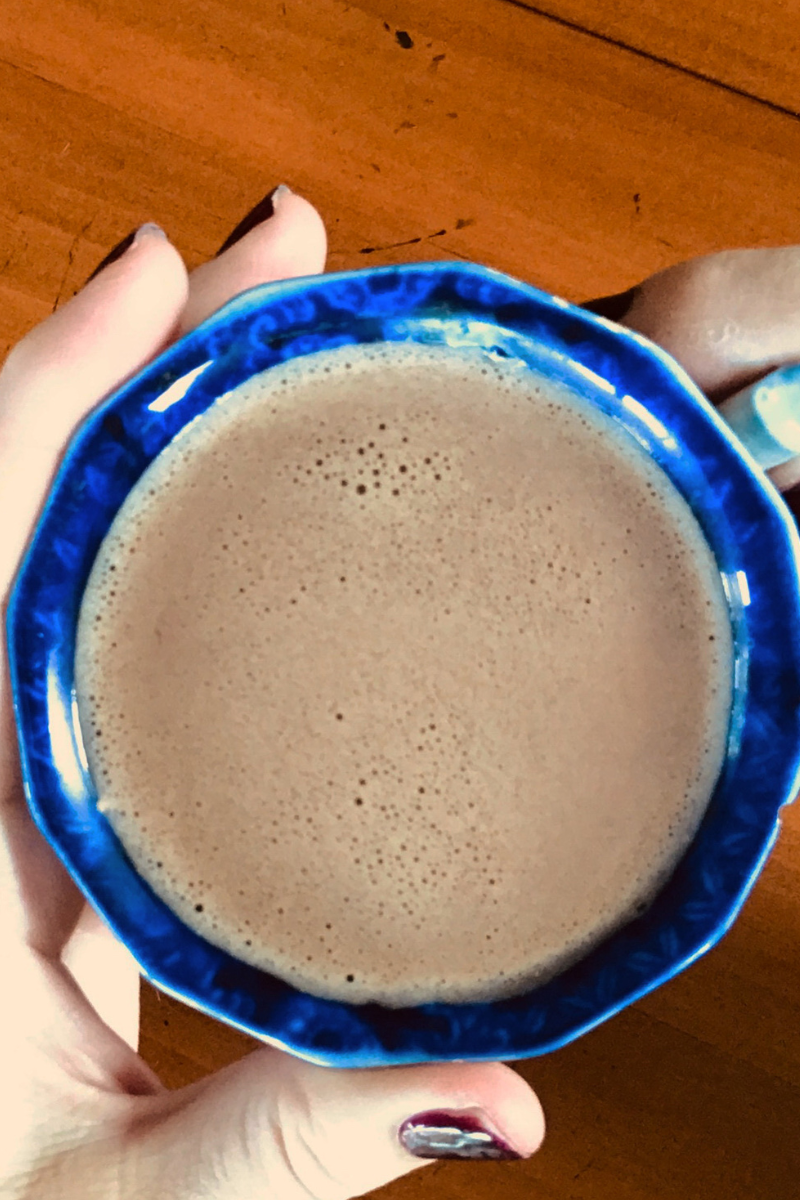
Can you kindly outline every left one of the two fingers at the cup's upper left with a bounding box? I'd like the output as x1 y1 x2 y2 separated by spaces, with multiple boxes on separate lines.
0 227 188 596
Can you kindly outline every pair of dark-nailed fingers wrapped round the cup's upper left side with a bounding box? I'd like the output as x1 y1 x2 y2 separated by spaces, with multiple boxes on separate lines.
0 188 326 595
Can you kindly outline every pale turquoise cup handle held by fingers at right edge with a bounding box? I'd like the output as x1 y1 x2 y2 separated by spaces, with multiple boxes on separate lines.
717 364 800 470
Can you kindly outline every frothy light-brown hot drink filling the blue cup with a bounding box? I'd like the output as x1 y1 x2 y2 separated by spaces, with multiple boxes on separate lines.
76 346 733 1006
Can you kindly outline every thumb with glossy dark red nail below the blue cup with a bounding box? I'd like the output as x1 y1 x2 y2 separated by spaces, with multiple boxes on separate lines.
134 1048 545 1200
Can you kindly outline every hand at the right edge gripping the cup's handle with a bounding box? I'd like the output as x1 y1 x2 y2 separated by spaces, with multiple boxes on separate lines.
583 246 800 501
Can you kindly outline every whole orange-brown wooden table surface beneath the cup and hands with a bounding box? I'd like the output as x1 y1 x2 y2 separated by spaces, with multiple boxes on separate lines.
0 0 800 1200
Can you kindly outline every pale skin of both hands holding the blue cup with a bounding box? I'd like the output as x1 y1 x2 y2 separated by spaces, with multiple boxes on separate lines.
0 194 800 1200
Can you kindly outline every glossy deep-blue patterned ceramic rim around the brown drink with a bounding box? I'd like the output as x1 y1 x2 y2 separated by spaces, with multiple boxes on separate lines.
8 263 800 1067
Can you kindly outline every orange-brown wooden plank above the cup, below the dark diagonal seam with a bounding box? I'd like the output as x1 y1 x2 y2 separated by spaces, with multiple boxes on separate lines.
0 0 800 350
